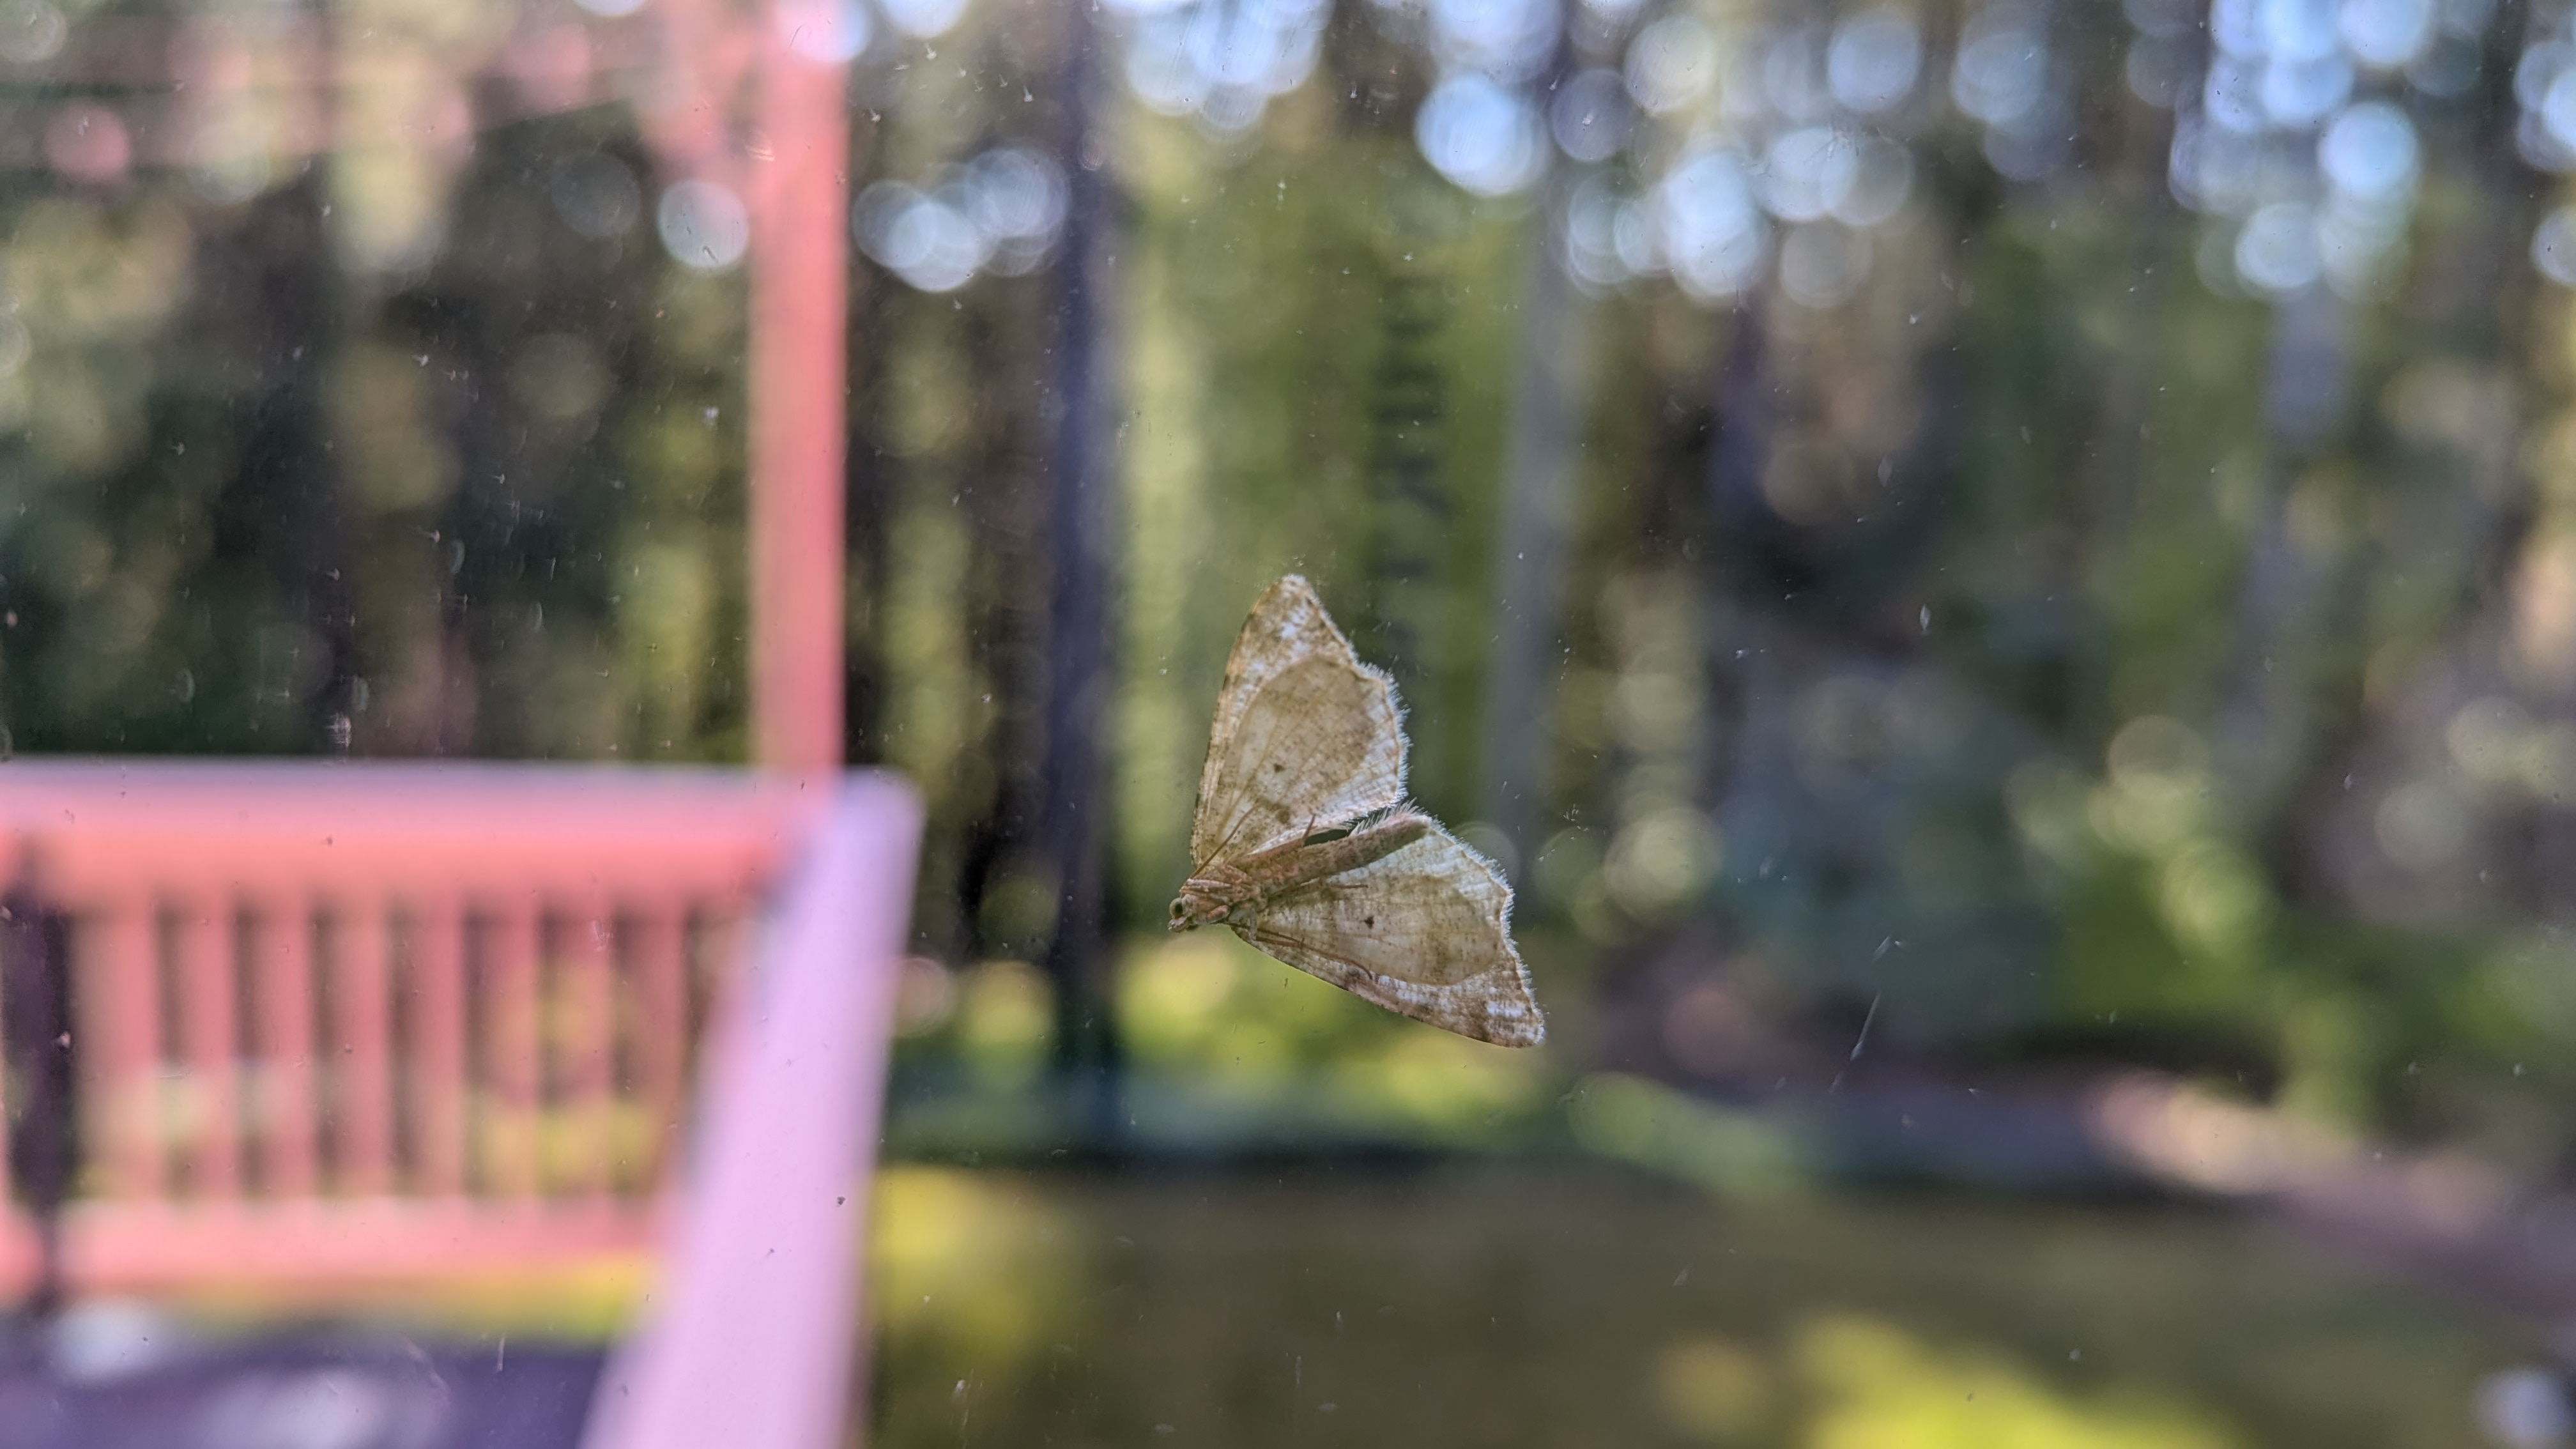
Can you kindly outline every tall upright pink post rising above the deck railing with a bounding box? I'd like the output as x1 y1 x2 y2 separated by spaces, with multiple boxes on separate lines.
749 0 850 771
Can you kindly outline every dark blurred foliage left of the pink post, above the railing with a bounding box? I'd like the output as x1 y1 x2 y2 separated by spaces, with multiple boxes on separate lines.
0 119 742 758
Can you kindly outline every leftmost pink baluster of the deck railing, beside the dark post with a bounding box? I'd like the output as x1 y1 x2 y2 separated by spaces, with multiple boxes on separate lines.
88 894 162 1199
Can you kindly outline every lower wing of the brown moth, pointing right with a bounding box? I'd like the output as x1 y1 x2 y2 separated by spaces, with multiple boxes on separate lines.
1234 827 1548 1046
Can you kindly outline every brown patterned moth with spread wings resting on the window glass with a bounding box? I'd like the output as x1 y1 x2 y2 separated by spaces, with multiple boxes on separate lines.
1170 575 1548 1046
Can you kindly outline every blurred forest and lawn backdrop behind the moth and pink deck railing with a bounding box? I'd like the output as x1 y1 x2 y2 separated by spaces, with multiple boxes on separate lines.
15 0 2576 1449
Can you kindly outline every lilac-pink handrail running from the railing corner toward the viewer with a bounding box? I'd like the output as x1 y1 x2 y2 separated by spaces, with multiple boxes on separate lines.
582 779 919 1449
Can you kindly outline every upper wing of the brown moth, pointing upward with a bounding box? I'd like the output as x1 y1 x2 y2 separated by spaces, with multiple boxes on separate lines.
1190 575 1404 869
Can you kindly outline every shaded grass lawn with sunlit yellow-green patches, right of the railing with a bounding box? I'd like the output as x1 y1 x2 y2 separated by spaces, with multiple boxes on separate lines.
871 1160 2543 1449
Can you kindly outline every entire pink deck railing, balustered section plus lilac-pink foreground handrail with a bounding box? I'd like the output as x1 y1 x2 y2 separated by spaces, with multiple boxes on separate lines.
0 760 919 1449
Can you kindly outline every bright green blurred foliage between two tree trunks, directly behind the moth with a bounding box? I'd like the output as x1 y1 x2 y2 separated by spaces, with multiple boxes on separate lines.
1118 105 1525 921
